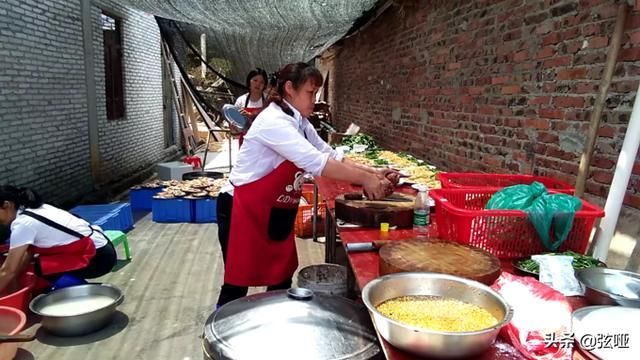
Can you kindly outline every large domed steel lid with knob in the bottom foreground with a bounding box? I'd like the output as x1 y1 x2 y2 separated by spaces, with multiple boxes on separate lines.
202 288 382 360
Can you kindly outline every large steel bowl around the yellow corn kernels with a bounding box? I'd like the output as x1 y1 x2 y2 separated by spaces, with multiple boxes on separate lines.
362 272 513 358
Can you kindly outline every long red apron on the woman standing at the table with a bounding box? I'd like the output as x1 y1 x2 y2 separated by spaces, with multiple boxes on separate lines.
224 160 304 286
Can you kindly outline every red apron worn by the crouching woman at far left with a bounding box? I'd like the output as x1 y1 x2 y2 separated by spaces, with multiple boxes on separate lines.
31 236 96 276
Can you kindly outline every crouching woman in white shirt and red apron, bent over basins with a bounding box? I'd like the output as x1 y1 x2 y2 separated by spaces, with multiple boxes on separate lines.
0 185 116 291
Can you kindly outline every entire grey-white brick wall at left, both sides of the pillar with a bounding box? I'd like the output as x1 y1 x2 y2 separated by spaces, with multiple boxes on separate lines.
0 0 175 203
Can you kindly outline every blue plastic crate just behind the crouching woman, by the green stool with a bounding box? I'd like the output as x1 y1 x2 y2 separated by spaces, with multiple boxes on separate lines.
70 203 133 232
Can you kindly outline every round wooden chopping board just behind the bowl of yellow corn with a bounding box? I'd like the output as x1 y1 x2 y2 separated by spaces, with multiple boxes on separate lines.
379 240 501 285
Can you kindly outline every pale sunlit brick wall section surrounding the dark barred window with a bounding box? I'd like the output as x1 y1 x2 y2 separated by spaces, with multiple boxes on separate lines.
92 0 174 181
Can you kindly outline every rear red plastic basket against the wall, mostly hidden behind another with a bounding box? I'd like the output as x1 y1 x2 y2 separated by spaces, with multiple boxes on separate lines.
437 172 575 195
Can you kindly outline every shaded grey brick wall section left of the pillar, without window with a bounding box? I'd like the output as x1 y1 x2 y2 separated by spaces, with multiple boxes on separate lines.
0 0 92 202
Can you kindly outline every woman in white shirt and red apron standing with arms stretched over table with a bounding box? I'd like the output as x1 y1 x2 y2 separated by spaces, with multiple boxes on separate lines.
218 63 398 306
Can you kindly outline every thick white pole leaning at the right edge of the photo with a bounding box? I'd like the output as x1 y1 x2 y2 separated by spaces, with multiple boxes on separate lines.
593 80 640 261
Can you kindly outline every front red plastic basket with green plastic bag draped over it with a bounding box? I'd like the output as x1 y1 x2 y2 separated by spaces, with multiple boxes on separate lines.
429 188 604 259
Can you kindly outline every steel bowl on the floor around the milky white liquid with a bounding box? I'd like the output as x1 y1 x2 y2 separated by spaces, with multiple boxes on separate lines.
29 284 124 336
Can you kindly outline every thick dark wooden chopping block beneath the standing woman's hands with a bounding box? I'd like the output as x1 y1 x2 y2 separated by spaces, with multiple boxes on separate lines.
335 192 415 228
